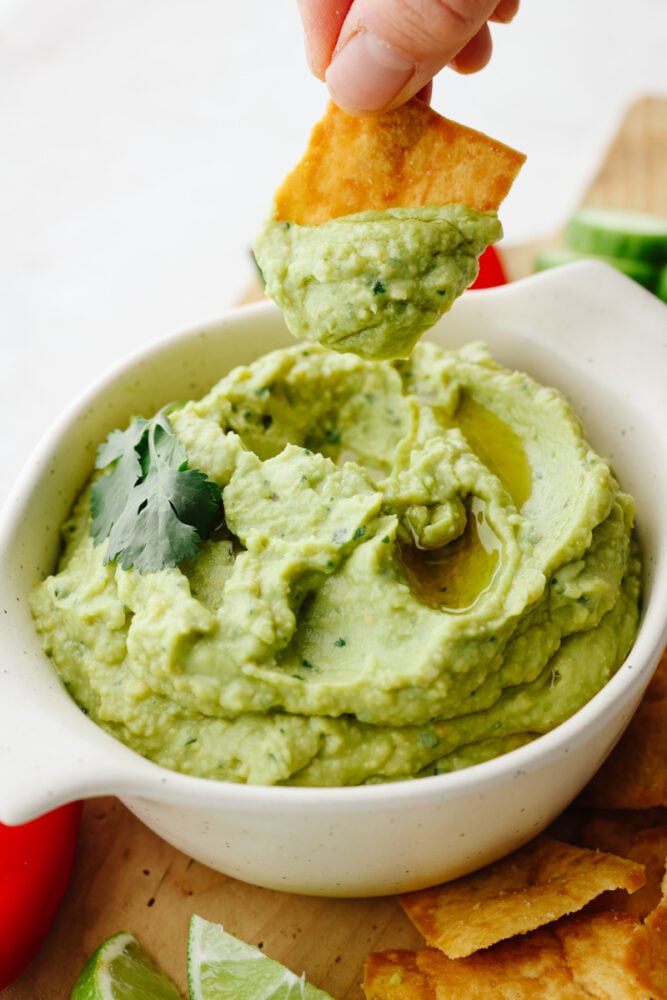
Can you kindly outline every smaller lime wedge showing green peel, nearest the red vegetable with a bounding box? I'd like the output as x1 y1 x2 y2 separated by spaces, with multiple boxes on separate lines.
72 931 181 1000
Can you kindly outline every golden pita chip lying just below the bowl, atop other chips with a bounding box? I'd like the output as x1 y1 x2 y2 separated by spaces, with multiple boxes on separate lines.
399 835 645 958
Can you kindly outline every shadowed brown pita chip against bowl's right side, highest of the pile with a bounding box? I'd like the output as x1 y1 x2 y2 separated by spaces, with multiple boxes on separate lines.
580 653 667 809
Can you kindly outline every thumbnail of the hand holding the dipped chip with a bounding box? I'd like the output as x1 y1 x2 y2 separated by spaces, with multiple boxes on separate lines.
325 31 415 111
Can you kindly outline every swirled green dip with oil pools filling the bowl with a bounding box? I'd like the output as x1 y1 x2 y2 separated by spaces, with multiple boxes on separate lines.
32 342 640 786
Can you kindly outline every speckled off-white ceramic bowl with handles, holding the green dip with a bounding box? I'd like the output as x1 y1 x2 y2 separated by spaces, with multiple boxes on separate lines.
0 264 667 896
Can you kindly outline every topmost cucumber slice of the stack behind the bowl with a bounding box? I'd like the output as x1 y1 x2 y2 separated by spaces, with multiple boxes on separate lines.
565 206 667 264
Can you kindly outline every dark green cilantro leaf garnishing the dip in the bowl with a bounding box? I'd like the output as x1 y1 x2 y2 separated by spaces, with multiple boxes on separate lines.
90 410 222 573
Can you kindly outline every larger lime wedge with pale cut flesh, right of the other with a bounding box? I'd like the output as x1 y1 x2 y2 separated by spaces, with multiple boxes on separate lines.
188 916 331 1000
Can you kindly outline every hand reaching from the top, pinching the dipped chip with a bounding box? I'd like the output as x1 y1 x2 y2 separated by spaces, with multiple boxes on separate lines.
297 0 519 113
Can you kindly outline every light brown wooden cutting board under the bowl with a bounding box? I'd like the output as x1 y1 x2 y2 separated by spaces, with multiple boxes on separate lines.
3 97 667 1000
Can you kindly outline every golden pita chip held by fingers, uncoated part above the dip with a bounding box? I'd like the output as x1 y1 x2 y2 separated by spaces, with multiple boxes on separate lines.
274 97 525 225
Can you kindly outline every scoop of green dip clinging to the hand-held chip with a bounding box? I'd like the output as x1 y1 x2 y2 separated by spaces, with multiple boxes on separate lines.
254 204 502 359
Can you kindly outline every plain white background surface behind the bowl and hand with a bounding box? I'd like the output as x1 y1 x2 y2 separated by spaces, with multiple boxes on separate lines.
0 0 667 502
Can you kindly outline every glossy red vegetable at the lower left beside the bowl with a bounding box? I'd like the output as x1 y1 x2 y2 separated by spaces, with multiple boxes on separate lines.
0 802 81 990
